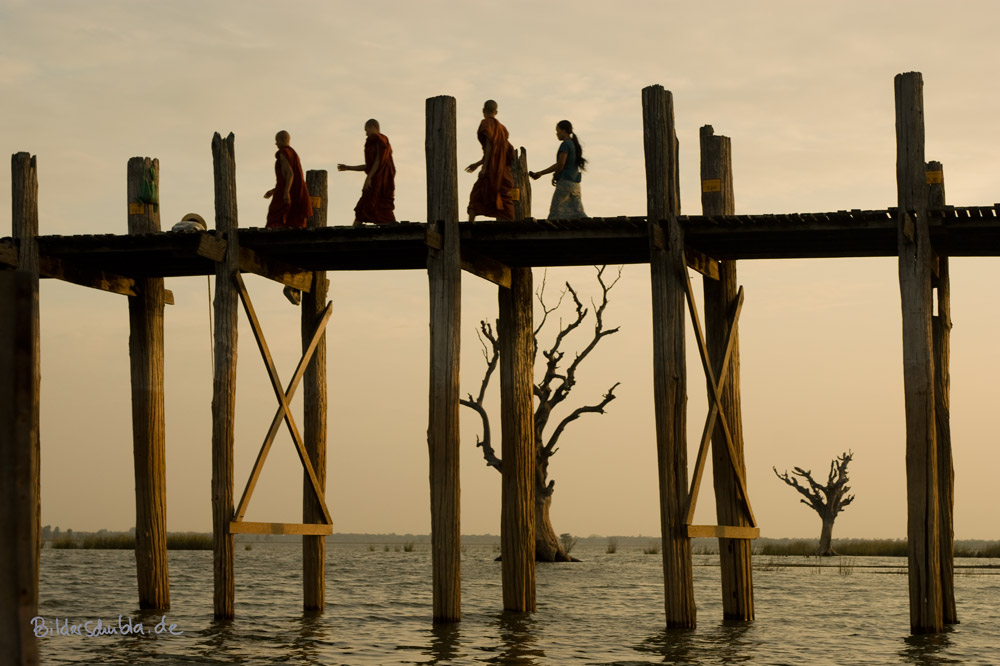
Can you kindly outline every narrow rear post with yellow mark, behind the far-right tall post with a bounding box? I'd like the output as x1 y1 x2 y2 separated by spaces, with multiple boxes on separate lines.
926 162 958 624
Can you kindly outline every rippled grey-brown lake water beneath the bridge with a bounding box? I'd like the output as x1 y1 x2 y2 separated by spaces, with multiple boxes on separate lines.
39 544 1000 666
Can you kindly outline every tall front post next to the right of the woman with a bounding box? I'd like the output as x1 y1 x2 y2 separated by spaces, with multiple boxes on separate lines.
642 86 697 627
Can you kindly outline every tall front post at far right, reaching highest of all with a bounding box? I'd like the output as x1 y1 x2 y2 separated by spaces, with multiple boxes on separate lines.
895 72 943 633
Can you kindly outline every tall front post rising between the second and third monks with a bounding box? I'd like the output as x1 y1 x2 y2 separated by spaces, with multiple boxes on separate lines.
424 96 462 622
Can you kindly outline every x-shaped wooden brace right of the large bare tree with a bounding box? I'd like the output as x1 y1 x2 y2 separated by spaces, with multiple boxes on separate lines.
681 255 757 527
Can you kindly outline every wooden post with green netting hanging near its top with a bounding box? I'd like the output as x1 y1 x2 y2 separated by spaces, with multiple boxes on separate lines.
127 157 170 609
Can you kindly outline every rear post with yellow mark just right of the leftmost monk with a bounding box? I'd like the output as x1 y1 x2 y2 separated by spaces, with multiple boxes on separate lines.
301 171 329 610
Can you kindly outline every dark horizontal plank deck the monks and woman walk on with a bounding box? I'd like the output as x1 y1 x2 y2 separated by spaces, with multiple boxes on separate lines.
0 204 1000 278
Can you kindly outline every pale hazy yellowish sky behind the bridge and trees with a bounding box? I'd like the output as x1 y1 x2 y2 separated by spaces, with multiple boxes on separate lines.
0 0 1000 539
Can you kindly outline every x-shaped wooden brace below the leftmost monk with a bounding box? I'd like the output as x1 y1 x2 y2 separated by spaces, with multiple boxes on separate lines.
233 272 333 525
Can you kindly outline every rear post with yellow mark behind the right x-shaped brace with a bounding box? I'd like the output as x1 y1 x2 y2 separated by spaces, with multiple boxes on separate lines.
701 125 754 620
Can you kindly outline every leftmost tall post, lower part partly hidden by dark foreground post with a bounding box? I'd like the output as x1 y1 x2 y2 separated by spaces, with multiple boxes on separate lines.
10 153 42 624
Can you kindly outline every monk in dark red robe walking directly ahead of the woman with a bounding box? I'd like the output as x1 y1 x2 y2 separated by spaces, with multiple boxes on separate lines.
465 99 514 222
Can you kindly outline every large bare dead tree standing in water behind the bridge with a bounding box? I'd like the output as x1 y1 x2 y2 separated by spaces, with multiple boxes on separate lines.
461 266 621 562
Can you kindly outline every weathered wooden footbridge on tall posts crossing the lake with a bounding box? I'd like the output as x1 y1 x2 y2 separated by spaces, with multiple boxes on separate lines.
0 73 984 654
